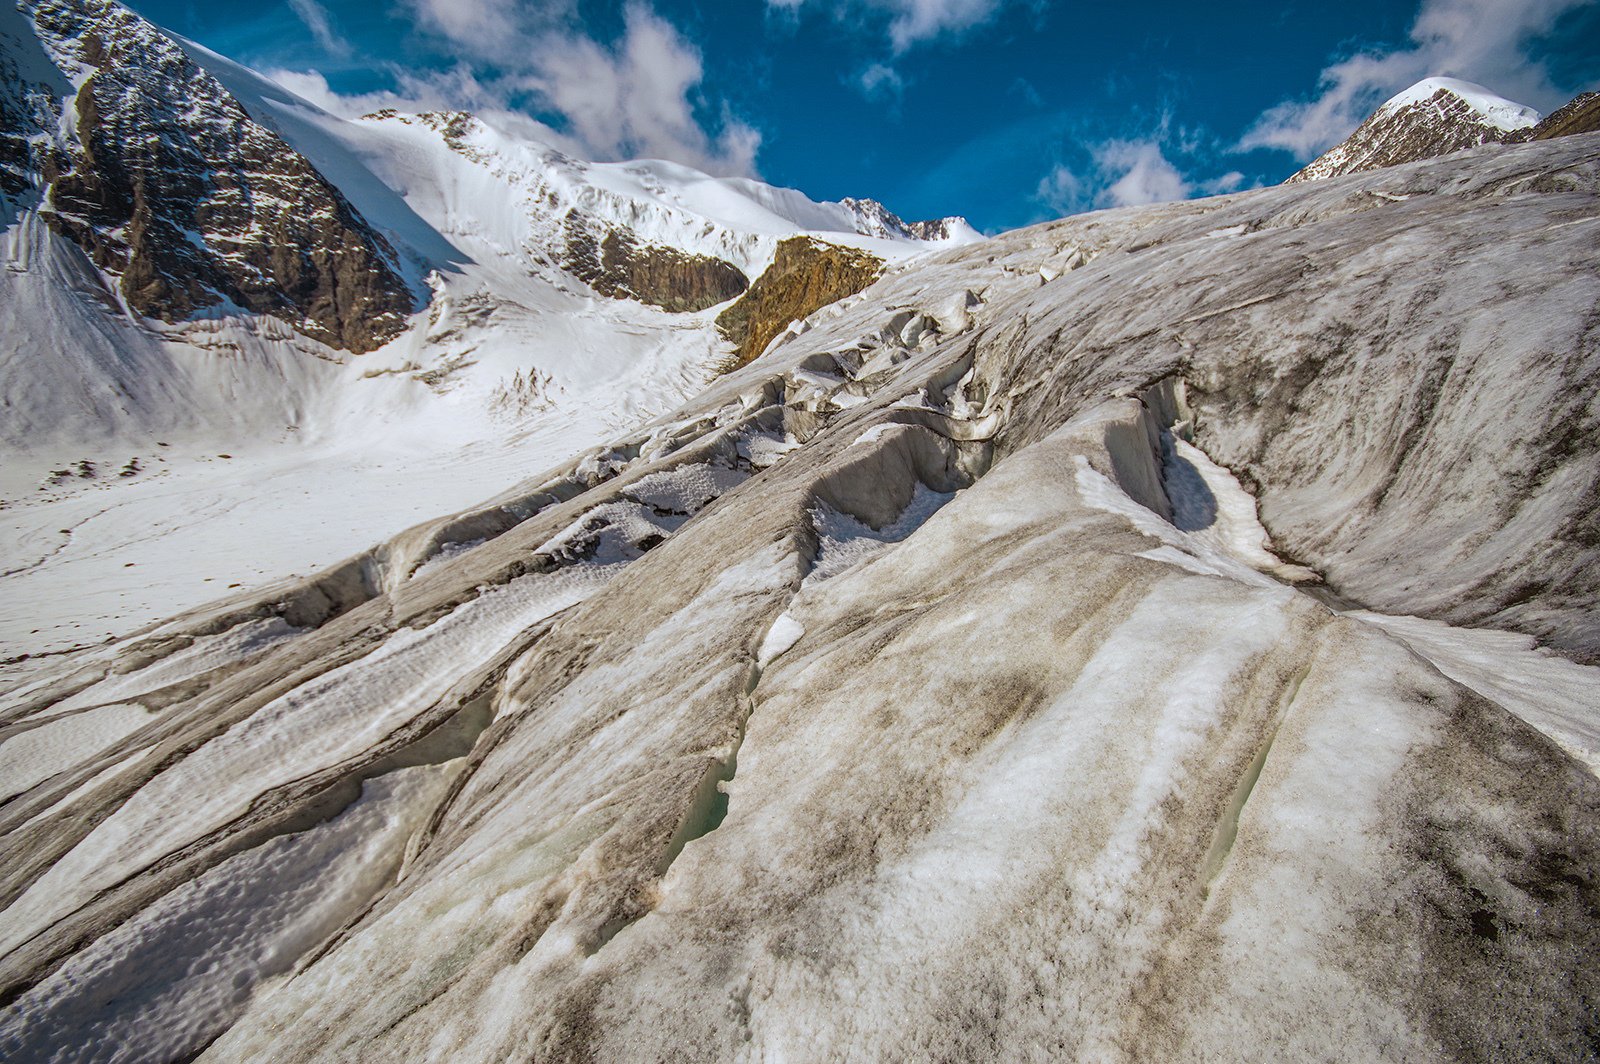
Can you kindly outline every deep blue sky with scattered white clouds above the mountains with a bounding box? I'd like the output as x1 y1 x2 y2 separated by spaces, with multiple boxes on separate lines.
131 0 1600 232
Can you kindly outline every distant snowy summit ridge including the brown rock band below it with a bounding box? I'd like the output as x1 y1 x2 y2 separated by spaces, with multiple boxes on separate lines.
337 104 982 312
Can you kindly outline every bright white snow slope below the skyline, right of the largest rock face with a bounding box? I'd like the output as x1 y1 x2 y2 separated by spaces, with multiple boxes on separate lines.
186 42 979 278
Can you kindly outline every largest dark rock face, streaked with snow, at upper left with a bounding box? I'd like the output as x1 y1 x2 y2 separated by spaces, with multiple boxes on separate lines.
14 0 414 352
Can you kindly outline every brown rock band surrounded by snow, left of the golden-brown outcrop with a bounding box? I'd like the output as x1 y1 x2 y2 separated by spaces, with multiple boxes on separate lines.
562 211 750 314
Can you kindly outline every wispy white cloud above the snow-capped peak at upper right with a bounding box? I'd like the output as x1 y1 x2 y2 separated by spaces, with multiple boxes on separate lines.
1238 0 1594 160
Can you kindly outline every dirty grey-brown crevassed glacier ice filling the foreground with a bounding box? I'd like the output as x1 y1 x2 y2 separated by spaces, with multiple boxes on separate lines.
0 136 1600 1062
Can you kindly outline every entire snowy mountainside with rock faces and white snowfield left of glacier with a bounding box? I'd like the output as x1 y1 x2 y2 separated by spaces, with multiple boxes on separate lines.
0 0 979 656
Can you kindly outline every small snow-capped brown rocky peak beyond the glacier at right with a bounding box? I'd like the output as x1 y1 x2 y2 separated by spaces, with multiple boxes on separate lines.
1290 77 1600 181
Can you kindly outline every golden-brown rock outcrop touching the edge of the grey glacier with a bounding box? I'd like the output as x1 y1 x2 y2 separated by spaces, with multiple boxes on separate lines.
717 237 883 366
